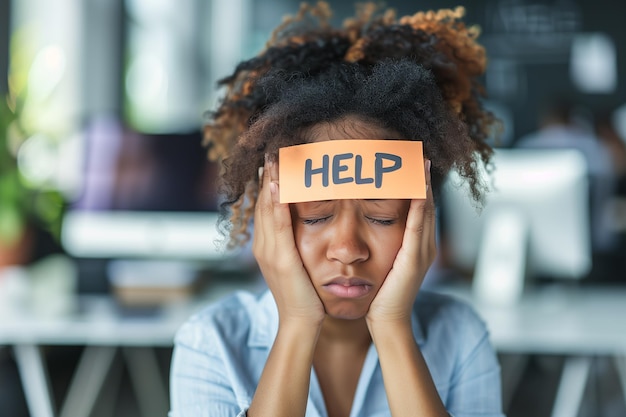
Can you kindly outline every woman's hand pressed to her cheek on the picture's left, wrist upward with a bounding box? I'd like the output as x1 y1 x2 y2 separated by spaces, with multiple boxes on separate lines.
252 158 325 325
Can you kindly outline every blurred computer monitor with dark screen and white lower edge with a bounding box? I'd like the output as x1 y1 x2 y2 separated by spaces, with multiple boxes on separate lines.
61 117 233 261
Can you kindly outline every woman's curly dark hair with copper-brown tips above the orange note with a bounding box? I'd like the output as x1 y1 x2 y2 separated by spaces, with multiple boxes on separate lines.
204 2 497 246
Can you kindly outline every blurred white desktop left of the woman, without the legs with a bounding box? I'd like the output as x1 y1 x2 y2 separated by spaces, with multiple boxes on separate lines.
0 282 258 347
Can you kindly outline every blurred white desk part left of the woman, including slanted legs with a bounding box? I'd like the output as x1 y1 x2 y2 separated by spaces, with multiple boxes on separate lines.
0 264 259 417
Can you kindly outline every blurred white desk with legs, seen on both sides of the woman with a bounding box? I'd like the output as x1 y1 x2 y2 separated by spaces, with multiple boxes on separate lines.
0 258 626 417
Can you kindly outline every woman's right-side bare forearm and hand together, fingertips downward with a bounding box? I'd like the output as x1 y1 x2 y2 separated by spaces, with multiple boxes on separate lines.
367 161 448 417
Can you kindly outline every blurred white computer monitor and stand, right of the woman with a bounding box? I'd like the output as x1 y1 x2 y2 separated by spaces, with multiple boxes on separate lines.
441 149 591 303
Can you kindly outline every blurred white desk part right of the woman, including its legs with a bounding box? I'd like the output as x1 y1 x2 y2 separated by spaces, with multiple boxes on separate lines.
436 286 626 417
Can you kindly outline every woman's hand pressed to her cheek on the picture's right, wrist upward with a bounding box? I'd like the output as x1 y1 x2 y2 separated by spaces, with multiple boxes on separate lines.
367 160 437 323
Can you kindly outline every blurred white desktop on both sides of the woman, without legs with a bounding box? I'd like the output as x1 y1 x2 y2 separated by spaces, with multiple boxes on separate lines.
0 266 626 354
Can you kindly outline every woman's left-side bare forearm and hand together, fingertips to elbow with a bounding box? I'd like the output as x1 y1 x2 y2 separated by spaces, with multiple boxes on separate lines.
248 157 324 417
